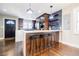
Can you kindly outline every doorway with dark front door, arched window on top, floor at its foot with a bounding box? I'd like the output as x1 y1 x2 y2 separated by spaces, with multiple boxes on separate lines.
5 19 16 45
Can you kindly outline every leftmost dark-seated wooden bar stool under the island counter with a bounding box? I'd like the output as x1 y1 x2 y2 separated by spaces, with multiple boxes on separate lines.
29 34 39 55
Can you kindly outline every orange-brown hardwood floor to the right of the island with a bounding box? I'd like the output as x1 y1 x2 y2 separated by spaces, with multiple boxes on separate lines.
31 43 79 56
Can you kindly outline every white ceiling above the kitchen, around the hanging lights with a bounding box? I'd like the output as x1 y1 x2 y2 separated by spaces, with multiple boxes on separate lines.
0 3 70 19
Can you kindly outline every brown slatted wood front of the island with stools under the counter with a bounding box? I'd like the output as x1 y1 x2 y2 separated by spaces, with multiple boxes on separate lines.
26 32 59 56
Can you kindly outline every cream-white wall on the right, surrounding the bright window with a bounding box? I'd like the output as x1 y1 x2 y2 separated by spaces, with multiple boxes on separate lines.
60 4 79 48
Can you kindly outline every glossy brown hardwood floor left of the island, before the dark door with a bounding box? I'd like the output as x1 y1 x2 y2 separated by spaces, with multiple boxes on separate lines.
0 40 23 56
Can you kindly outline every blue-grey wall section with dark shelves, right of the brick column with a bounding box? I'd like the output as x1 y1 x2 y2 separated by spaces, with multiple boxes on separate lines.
49 10 62 30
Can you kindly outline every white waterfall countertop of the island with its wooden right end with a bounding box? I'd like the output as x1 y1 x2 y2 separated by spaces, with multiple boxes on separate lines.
23 30 61 56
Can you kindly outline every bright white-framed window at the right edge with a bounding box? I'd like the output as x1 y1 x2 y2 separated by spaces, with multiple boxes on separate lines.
72 7 79 34
